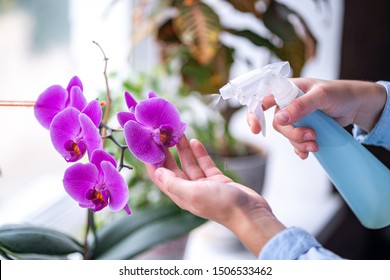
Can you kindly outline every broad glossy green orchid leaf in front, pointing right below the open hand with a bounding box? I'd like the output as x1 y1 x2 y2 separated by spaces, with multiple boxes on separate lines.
98 211 205 260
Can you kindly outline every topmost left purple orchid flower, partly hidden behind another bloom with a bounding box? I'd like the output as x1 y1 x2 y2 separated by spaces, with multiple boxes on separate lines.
34 76 102 129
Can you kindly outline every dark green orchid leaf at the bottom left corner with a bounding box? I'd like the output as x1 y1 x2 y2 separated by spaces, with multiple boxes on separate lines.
0 225 83 256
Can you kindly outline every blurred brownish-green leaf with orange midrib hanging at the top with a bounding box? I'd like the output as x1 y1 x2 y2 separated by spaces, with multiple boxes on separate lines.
173 1 221 65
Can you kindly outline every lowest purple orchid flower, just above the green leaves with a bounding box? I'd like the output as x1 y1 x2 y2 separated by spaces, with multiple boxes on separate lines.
63 150 131 215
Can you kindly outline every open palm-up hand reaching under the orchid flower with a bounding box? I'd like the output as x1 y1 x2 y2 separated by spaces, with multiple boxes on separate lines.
147 136 284 255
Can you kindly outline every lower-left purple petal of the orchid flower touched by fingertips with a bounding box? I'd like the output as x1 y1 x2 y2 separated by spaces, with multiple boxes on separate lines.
124 121 165 165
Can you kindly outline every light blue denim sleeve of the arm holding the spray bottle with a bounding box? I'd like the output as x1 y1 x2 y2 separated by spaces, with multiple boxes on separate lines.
353 81 390 150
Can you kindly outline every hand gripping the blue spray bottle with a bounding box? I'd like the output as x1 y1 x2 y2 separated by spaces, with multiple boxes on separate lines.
248 78 386 159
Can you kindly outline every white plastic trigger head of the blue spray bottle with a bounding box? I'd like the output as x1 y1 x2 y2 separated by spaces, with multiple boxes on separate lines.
219 61 300 136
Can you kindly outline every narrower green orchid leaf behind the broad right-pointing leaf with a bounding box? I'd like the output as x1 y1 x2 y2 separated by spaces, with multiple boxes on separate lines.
93 203 181 258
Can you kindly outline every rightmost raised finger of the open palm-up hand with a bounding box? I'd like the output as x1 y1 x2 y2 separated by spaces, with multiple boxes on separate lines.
190 139 230 181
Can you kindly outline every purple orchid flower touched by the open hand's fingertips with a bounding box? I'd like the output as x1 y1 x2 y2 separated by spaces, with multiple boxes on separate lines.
117 92 186 166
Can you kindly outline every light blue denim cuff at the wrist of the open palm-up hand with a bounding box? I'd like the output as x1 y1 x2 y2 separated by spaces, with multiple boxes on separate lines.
258 227 342 260
